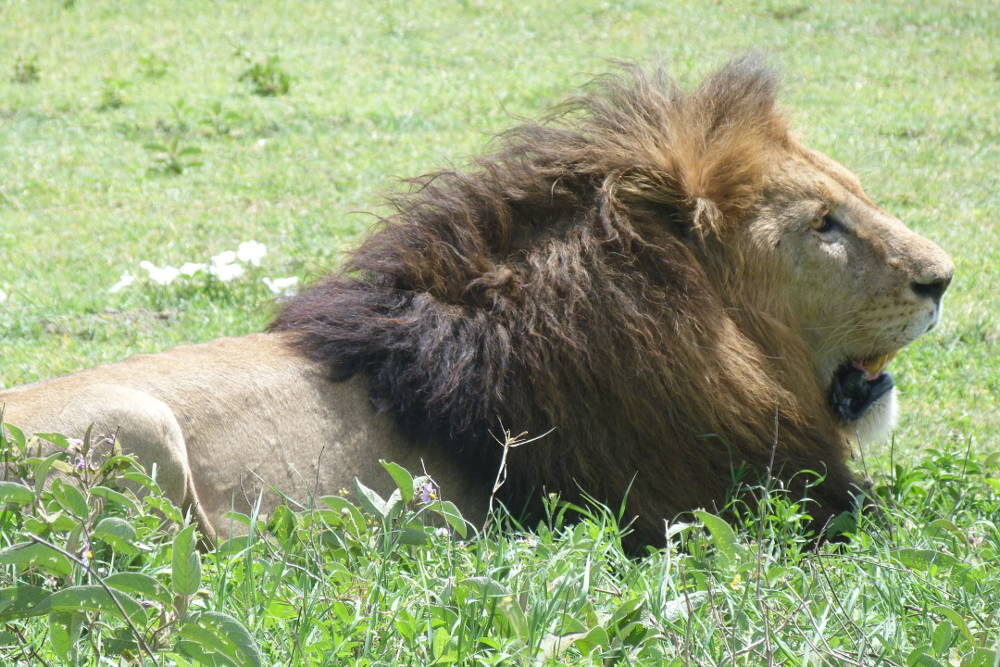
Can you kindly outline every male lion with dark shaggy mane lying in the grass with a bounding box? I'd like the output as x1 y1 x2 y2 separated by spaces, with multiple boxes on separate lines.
0 57 953 542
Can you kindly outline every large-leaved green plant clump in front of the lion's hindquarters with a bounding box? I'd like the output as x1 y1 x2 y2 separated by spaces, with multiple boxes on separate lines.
0 425 261 666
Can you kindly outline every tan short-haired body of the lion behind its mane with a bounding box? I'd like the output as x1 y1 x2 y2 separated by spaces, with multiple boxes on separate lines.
0 334 487 538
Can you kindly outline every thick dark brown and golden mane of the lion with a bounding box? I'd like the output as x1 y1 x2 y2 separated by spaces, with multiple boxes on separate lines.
273 57 843 541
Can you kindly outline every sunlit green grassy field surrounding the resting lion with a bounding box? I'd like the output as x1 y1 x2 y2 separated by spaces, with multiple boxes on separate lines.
0 0 1000 665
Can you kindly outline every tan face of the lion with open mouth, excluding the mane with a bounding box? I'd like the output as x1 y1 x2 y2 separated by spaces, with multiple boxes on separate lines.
746 146 954 442
